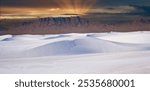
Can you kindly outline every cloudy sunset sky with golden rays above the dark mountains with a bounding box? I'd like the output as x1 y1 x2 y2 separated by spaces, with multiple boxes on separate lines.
0 0 150 17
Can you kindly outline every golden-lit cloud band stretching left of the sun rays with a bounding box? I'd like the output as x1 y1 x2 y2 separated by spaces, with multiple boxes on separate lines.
0 7 62 19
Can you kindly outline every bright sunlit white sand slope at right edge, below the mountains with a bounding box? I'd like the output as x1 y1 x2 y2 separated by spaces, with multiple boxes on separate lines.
100 32 150 44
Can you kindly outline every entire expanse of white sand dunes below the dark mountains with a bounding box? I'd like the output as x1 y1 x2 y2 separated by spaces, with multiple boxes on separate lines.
0 31 150 73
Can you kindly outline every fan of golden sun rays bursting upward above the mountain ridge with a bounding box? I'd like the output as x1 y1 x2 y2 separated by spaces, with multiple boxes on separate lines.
56 0 96 14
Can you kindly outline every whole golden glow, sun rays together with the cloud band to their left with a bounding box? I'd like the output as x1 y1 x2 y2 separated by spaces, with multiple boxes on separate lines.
0 0 95 19
